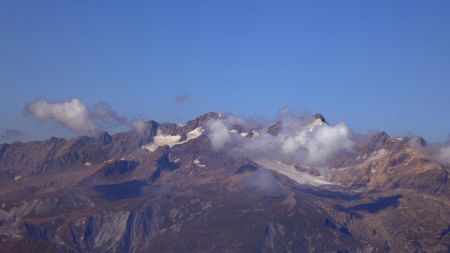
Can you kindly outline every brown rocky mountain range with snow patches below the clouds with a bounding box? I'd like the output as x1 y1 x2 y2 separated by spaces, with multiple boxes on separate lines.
0 113 450 252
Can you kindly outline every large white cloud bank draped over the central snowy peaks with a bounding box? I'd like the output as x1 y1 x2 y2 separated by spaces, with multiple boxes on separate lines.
207 110 354 166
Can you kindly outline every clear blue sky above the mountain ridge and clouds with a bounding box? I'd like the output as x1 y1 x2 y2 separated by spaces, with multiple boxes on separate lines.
0 0 450 142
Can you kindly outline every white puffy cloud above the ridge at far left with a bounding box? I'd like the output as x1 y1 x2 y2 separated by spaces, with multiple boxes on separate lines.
26 98 128 134
